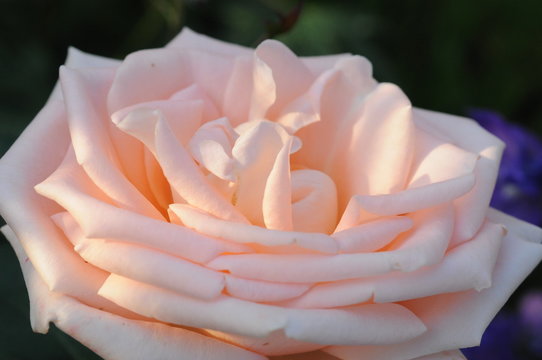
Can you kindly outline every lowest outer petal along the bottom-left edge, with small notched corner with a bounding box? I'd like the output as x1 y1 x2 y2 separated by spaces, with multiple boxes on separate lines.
3 228 265 360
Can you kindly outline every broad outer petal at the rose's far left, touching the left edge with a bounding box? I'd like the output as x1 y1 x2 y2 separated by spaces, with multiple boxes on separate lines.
0 100 123 310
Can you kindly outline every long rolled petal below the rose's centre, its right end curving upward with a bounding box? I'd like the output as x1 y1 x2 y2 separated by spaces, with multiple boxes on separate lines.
208 205 453 283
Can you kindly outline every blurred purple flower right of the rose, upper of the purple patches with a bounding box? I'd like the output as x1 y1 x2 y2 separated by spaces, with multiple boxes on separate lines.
469 109 542 225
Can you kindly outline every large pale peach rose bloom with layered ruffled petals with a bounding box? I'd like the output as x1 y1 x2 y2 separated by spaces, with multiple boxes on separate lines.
0 29 542 360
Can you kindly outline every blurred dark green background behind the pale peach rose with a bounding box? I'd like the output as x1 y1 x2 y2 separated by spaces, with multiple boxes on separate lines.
0 0 542 360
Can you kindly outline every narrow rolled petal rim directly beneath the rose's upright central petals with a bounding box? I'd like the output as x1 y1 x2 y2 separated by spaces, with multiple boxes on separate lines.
169 204 337 255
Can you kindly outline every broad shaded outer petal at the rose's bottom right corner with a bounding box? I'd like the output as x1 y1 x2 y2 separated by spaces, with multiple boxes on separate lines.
325 211 542 360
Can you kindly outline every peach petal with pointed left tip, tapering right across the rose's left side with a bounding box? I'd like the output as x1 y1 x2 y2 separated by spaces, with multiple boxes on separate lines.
33 153 249 262
